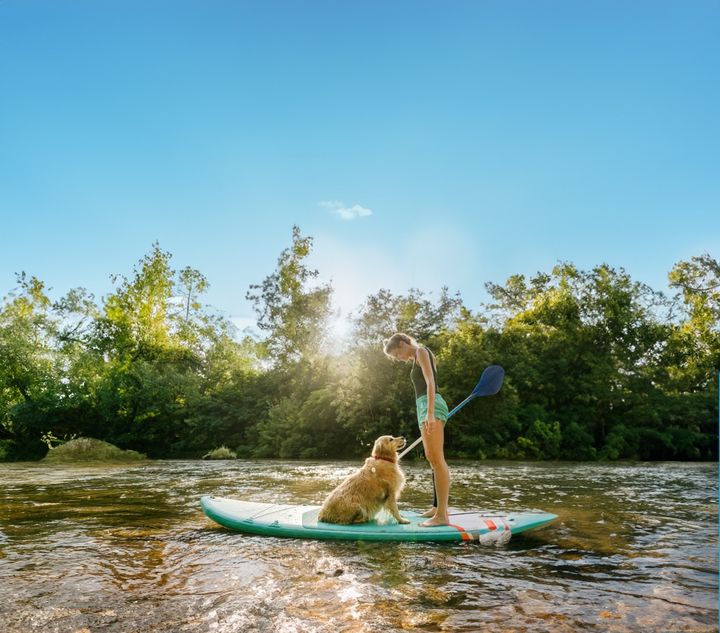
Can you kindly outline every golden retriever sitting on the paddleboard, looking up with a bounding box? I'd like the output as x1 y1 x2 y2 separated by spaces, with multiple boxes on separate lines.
318 435 410 524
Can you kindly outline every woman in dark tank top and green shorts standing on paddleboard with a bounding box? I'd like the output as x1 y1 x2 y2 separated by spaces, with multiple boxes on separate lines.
384 332 450 527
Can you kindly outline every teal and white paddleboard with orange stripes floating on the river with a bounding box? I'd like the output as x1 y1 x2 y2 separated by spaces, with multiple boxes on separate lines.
200 496 557 543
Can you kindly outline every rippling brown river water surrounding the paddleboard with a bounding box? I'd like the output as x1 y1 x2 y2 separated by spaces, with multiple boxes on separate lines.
0 460 718 633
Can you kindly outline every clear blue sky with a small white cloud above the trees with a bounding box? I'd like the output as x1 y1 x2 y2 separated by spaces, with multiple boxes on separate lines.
0 0 720 334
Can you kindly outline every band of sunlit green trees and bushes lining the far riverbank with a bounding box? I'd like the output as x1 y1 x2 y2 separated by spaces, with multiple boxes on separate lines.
0 227 720 461
